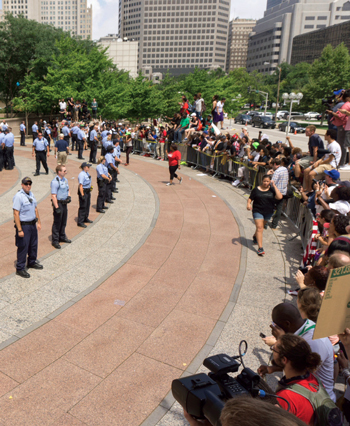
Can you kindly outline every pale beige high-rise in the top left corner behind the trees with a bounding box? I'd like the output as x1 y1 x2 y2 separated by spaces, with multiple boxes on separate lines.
2 0 92 38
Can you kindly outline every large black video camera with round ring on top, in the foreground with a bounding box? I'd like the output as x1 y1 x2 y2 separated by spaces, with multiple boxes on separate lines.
171 340 276 426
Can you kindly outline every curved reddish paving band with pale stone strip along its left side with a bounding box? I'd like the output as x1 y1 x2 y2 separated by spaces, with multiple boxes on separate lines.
0 146 241 426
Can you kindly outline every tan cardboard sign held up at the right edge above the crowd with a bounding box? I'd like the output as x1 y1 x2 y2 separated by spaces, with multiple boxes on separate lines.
313 265 350 340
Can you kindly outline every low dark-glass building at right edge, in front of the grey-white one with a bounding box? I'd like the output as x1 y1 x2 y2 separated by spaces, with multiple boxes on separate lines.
291 21 350 65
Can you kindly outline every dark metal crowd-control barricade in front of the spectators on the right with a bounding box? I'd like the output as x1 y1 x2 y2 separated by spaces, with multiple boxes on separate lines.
133 140 314 255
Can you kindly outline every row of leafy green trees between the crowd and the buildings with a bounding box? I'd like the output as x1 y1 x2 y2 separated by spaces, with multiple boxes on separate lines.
4 15 350 121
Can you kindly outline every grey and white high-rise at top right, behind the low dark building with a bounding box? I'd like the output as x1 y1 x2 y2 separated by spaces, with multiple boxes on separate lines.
247 0 350 73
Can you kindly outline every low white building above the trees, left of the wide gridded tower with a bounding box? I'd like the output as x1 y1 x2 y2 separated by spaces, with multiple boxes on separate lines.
98 34 139 77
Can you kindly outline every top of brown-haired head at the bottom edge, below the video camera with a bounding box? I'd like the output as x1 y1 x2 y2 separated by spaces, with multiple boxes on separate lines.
184 397 306 426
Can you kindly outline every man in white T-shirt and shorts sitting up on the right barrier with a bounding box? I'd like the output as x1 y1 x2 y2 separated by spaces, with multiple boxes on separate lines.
304 129 341 191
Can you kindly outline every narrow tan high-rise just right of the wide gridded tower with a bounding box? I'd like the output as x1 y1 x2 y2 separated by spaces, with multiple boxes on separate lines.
226 18 256 72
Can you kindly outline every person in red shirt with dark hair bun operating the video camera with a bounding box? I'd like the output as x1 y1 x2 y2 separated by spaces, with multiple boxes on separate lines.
258 334 322 425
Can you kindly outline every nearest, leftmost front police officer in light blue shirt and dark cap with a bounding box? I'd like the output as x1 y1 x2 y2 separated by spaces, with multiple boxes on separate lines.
13 177 43 278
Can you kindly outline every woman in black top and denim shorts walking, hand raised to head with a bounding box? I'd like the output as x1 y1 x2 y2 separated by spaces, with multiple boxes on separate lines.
247 175 283 256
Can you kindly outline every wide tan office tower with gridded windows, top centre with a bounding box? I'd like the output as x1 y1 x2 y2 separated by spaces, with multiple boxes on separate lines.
119 0 231 75
